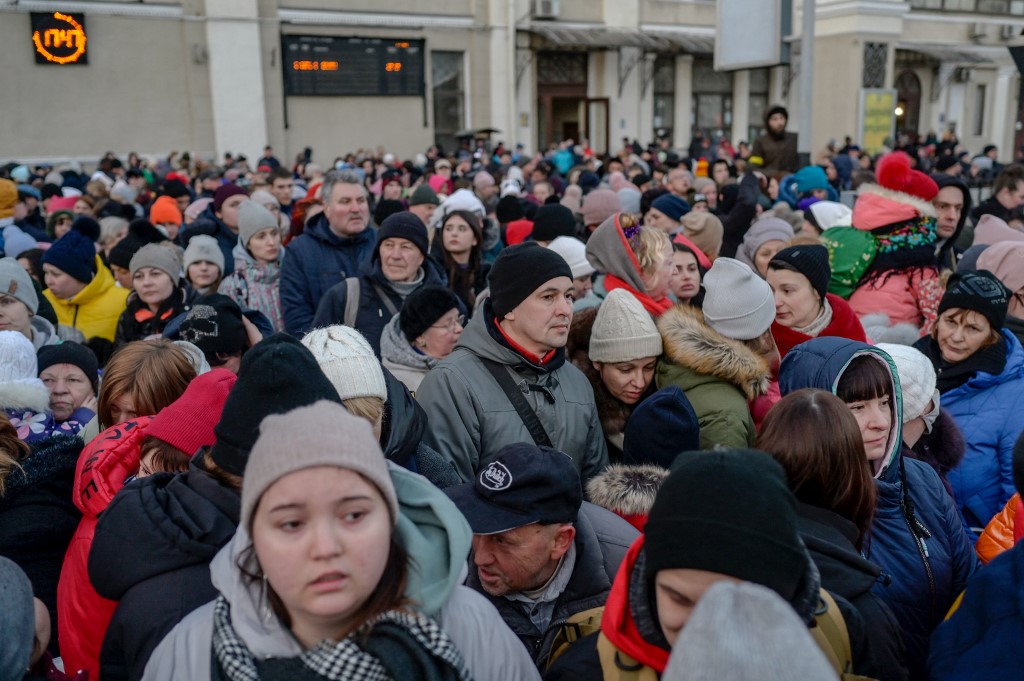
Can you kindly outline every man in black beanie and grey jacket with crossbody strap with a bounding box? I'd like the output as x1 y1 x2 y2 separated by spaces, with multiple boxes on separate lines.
417 242 608 481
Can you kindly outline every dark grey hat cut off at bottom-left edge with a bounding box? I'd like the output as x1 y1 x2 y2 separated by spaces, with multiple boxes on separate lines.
0 556 36 679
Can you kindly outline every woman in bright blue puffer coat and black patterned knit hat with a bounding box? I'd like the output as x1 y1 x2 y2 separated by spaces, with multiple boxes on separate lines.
914 269 1024 528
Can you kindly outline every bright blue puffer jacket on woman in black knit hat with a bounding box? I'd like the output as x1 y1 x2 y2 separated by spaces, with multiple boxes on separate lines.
942 329 1024 527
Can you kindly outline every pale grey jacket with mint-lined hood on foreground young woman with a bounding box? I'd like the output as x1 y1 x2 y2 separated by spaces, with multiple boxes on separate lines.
142 464 540 681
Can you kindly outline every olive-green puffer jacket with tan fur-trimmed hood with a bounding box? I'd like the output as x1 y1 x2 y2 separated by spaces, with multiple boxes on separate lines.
655 305 771 450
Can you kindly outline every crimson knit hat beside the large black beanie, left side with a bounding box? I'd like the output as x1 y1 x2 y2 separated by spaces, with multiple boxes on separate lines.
145 369 238 455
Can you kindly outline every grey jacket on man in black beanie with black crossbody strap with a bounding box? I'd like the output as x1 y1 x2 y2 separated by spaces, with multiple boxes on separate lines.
417 299 608 482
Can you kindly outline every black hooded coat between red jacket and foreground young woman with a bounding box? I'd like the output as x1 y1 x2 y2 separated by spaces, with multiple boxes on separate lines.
89 455 241 681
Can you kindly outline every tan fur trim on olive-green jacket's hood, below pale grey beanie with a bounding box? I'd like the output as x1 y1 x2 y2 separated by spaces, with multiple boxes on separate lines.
657 305 771 399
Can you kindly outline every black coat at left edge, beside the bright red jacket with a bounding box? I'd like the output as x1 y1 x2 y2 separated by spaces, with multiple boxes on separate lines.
0 435 85 655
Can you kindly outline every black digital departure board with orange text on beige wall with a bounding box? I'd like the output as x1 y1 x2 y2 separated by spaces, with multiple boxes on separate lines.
282 35 425 97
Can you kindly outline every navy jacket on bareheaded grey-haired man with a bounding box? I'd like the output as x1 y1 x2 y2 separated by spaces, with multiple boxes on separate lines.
281 213 377 337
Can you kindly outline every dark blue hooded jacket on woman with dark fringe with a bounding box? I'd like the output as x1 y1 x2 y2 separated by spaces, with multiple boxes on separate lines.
779 338 978 679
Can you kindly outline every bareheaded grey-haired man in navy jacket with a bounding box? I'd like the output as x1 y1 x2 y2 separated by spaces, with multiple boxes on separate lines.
281 170 376 336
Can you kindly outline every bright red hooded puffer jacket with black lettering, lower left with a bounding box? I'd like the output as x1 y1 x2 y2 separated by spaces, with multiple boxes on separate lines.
57 416 152 679
